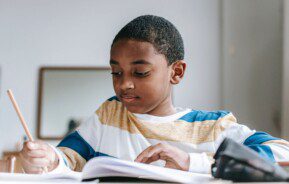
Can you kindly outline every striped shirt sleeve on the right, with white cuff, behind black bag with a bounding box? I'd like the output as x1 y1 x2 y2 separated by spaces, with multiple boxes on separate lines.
189 113 289 173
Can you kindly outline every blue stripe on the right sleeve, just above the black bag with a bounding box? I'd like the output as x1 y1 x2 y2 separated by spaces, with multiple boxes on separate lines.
243 132 279 162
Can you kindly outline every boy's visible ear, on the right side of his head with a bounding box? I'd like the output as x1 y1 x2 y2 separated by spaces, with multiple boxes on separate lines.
170 60 186 84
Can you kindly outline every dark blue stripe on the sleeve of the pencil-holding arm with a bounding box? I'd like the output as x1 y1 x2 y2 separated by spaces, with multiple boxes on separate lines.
57 131 109 161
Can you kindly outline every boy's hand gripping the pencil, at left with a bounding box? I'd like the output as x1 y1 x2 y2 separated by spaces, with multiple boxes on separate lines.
20 141 59 174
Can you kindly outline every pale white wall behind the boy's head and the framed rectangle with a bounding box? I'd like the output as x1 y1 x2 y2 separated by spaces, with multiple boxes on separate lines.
0 0 221 155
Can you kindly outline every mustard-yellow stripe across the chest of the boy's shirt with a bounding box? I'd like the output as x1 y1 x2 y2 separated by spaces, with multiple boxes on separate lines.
96 100 236 144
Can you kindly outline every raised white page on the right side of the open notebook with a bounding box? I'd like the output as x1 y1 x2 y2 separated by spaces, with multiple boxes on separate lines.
83 157 212 183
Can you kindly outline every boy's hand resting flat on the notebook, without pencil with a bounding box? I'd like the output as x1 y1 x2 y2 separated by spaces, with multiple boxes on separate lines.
135 143 190 171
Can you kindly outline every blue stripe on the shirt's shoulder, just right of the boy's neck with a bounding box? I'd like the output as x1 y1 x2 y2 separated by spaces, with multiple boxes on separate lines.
179 110 230 123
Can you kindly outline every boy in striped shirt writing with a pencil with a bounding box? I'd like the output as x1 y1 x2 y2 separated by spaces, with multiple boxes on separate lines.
20 15 289 173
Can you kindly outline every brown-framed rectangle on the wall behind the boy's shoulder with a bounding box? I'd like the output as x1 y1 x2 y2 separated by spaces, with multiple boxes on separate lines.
37 67 114 140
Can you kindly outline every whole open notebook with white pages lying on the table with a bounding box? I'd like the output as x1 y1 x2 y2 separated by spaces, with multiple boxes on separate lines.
0 157 212 183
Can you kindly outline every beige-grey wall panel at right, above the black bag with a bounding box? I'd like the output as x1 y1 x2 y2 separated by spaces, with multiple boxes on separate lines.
222 0 283 137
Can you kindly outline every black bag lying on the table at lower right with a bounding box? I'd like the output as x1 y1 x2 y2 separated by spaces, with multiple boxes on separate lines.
211 138 289 182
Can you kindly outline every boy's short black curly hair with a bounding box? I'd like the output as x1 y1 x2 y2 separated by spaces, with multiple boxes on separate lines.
111 15 185 65
